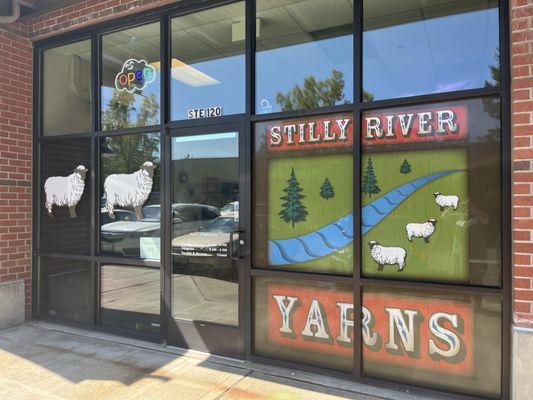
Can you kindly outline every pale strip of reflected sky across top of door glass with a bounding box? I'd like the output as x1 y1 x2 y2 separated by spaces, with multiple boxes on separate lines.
172 132 239 160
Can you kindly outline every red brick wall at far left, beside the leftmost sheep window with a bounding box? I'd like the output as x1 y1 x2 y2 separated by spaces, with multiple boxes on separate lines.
0 25 32 316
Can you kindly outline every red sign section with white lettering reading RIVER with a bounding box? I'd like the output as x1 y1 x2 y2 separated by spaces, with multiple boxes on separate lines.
361 105 468 146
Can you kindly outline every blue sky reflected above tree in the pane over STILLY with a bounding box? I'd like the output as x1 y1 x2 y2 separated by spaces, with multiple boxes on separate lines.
256 35 353 114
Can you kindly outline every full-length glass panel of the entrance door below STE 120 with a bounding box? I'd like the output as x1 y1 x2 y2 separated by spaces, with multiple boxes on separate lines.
171 132 239 325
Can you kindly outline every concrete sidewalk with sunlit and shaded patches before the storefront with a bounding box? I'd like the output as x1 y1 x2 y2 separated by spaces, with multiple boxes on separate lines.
0 322 436 400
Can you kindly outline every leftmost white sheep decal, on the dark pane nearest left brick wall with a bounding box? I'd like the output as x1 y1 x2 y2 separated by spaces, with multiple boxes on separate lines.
44 165 88 218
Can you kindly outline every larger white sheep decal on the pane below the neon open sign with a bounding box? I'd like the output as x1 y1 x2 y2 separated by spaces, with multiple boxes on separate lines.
104 161 155 219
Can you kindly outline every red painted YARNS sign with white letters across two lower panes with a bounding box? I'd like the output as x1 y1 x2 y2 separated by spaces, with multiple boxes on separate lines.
267 284 474 376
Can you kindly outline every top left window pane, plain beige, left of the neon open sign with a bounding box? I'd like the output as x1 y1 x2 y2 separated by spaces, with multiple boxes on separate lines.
42 40 92 136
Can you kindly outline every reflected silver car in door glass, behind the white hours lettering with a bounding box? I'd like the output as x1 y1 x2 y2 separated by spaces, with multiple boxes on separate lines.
172 213 239 257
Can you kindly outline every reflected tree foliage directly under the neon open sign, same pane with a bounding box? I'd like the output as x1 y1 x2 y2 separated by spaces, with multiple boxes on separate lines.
102 90 159 130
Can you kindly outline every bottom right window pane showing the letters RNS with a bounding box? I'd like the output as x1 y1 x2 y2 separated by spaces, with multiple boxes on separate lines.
362 287 501 398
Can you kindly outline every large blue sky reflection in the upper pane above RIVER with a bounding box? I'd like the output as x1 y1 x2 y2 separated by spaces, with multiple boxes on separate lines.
363 8 498 100
